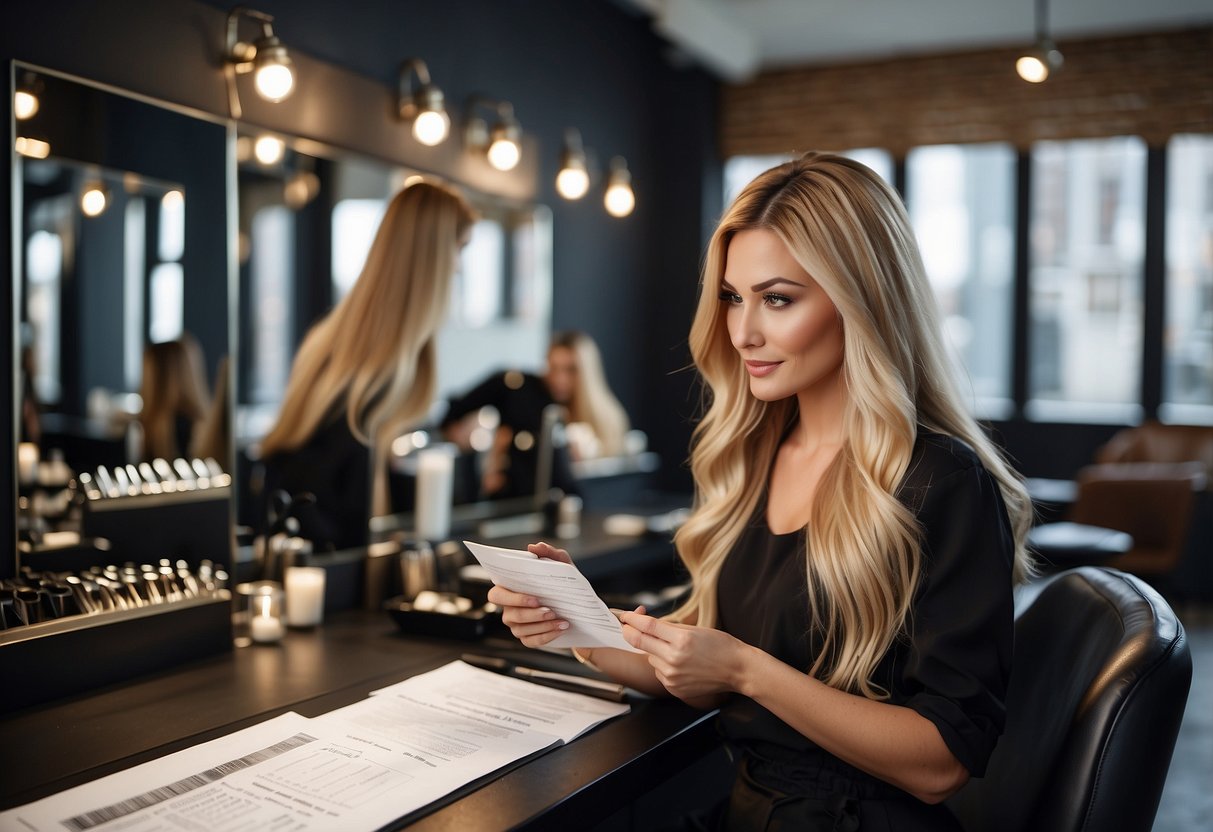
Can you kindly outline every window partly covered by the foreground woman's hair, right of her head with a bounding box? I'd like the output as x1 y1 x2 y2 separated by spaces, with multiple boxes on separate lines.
906 144 1015 417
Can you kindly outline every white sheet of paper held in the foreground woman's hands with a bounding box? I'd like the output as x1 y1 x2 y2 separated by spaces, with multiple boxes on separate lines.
463 540 640 653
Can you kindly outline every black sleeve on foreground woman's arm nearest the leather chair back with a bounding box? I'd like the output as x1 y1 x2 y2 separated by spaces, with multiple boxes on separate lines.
899 465 1014 776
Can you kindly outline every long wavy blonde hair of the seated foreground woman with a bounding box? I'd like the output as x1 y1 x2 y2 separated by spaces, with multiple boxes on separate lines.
672 153 1031 699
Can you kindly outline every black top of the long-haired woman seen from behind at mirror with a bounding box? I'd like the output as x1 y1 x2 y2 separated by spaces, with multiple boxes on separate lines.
260 410 371 551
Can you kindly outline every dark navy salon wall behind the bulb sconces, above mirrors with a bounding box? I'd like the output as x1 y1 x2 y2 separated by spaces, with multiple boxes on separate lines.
0 0 721 574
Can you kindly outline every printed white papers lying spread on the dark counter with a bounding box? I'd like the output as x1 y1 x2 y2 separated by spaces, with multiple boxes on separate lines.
0 661 630 832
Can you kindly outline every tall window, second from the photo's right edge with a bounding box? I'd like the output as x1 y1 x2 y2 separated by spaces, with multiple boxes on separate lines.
1027 137 1146 422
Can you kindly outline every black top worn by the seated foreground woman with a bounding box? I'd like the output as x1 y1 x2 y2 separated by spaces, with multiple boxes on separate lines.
718 429 1014 782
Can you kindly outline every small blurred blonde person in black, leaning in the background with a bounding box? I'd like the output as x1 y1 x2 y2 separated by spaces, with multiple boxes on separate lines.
442 331 628 498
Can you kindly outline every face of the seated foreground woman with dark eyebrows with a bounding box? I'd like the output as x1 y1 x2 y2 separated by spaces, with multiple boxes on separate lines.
721 229 843 401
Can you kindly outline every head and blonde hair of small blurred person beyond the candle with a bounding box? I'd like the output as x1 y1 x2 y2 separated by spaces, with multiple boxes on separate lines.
543 330 628 457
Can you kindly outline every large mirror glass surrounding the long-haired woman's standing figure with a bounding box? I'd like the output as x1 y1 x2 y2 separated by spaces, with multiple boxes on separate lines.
235 125 552 548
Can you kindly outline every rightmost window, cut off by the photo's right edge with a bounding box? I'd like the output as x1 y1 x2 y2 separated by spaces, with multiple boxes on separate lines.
1160 135 1213 424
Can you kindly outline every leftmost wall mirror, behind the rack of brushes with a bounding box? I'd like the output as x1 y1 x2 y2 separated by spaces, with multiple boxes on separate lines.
12 64 232 572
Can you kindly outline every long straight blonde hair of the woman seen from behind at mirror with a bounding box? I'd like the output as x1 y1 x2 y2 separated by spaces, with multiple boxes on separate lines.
261 182 475 508
